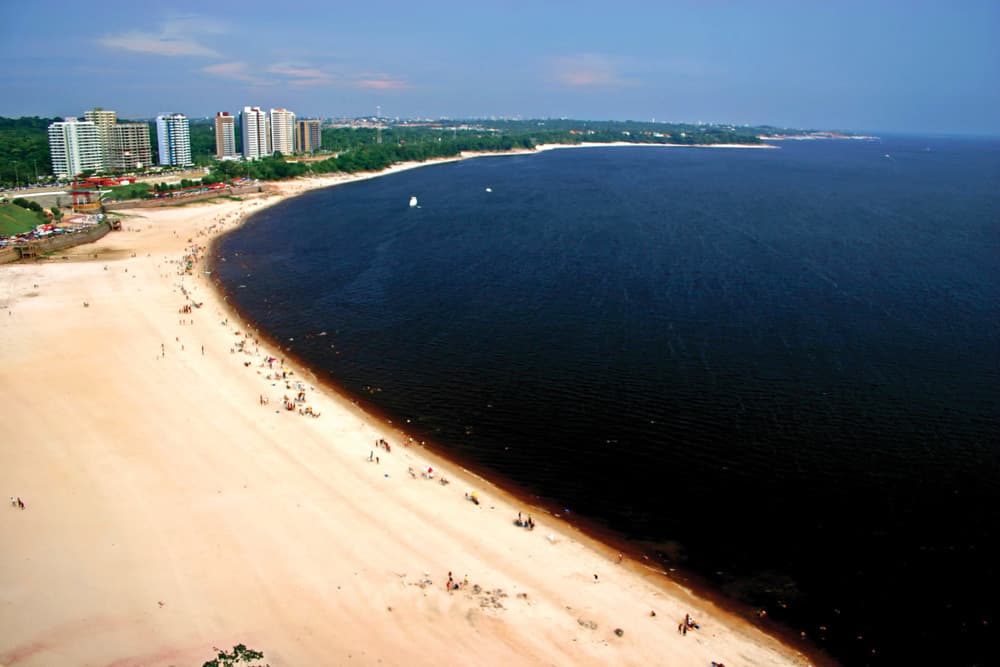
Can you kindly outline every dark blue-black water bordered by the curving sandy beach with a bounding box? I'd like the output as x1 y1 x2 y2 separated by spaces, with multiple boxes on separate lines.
217 138 1000 665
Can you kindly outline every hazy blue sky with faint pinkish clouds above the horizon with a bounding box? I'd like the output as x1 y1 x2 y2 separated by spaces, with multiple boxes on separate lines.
0 0 1000 135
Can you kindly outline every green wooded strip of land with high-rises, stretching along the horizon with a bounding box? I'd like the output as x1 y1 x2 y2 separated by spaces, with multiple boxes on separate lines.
0 114 872 193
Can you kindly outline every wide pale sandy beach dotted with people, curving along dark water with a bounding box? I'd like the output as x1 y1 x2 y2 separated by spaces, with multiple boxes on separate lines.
0 165 809 667
